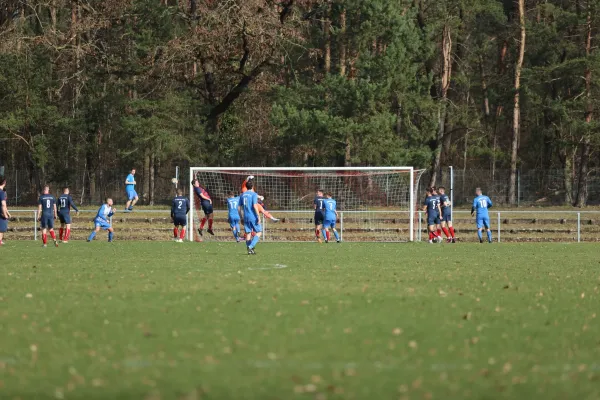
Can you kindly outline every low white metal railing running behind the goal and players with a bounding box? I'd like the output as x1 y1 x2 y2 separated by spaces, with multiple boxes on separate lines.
9 209 600 242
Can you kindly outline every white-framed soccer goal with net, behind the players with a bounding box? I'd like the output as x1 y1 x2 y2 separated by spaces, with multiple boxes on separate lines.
188 167 423 242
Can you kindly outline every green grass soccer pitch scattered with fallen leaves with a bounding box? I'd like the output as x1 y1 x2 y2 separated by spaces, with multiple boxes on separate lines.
0 242 600 400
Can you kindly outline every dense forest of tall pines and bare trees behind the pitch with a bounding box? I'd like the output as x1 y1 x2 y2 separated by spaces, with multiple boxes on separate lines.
0 0 600 206
